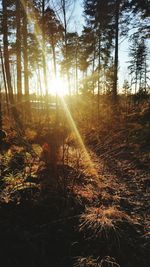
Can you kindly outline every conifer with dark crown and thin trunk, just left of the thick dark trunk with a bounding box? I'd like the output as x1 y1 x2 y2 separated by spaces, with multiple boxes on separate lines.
84 0 114 103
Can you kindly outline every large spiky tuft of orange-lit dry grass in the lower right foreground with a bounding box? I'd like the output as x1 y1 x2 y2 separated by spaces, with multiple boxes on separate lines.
80 206 133 244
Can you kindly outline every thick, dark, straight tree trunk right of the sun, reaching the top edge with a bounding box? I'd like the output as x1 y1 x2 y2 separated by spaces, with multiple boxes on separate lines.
113 0 120 104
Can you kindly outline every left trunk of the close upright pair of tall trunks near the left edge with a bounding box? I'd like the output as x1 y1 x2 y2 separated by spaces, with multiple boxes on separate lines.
16 0 22 101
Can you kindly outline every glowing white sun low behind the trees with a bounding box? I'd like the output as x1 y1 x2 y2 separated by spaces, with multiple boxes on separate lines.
49 78 68 97
